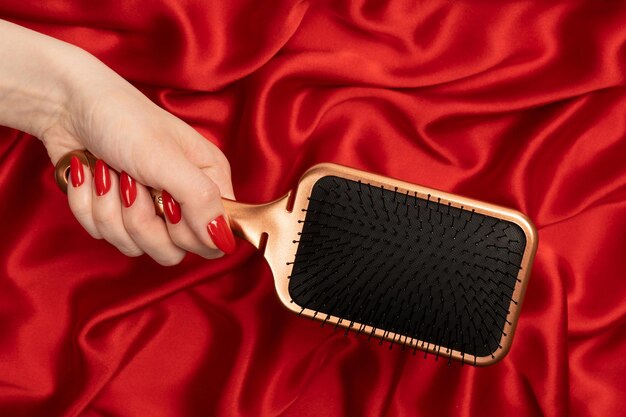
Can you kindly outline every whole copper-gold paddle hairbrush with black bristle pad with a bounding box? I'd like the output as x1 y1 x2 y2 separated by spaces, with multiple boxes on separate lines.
56 151 537 365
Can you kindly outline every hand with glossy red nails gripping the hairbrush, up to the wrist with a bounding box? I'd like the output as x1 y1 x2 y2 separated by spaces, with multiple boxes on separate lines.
0 19 234 265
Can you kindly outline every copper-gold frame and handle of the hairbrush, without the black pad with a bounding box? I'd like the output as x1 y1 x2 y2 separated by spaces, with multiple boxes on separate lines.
56 151 537 366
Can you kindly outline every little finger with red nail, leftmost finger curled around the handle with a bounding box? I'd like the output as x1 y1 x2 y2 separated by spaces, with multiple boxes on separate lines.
67 156 102 239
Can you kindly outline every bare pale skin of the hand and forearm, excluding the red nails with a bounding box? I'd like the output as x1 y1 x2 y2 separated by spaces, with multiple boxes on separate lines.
0 20 234 265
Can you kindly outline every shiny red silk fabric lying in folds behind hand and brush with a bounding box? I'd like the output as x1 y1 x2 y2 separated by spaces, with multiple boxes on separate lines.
0 0 626 417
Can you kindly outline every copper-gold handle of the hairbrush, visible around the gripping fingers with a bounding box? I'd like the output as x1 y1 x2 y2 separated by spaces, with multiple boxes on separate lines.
55 150 289 251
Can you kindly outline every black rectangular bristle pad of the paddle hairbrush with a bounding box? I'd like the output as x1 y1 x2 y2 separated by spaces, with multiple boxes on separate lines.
289 176 526 357
